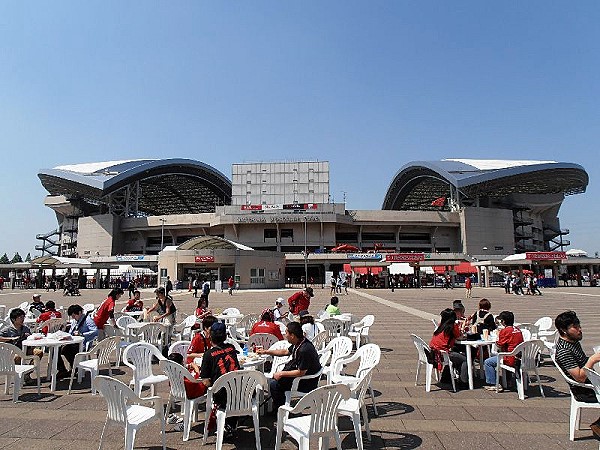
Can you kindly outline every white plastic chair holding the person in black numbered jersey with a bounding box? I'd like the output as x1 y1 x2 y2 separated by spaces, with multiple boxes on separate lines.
202 370 267 450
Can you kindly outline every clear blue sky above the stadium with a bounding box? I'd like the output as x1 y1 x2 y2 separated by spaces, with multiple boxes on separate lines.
0 0 600 257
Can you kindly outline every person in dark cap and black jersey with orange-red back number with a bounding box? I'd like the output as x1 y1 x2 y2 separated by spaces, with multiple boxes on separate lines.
200 322 240 436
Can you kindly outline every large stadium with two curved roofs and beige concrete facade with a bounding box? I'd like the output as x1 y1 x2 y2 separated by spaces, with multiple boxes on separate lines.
38 159 588 287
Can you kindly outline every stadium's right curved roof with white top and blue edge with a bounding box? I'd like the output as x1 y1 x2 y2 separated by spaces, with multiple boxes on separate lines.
382 159 589 210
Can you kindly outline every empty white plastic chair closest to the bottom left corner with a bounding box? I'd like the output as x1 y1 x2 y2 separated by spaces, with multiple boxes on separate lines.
94 375 166 450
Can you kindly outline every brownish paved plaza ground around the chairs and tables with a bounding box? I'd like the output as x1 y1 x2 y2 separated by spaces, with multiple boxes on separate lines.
0 286 600 450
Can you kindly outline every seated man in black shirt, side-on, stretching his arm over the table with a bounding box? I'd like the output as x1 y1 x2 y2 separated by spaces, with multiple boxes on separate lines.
256 322 321 411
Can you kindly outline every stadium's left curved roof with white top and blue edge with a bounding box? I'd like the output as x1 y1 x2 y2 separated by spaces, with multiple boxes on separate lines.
38 159 231 216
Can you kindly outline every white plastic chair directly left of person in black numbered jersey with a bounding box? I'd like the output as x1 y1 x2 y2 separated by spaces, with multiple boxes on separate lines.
159 360 206 441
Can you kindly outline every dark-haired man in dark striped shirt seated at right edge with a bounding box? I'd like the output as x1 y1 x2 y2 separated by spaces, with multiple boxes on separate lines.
554 311 600 439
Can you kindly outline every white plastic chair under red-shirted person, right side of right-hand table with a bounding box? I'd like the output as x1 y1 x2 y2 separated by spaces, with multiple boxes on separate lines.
496 339 545 400
